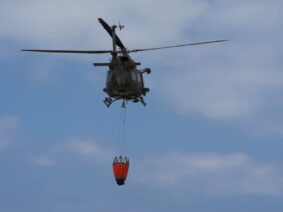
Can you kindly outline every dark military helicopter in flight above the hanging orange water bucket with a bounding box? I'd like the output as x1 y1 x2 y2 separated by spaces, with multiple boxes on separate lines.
22 18 227 107
